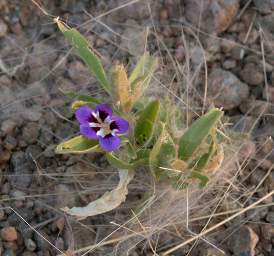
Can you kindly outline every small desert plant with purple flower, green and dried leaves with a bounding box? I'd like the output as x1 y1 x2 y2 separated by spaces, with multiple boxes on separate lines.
55 19 223 218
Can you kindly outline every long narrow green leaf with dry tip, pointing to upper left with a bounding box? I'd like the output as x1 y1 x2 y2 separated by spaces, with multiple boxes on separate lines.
56 20 111 95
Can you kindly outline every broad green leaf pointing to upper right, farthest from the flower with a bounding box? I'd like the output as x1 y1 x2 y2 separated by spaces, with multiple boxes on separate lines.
178 108 223 161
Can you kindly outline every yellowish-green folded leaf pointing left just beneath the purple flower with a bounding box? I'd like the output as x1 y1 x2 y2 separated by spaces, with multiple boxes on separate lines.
55 135 102 154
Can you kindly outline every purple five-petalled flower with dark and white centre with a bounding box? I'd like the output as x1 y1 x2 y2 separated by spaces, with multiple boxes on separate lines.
75 104 129 151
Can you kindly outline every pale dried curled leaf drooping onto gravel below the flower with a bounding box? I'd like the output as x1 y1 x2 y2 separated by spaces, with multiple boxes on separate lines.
62 170 134 219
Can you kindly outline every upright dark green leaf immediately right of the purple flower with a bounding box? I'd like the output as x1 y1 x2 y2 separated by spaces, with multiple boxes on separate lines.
134 100 160 146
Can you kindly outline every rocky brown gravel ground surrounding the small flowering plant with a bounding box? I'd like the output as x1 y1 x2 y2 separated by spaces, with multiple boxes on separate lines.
0 0 274 256
